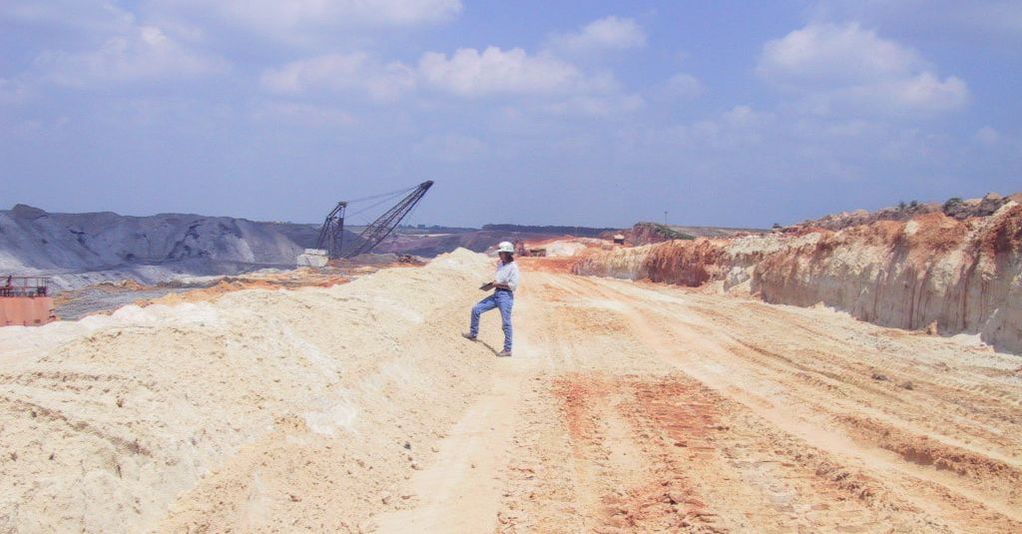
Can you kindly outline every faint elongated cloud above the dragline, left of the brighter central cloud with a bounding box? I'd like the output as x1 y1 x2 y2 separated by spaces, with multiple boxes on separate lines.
262 52 416 101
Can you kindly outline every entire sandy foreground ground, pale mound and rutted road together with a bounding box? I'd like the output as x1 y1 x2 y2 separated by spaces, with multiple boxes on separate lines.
6 251 1022 534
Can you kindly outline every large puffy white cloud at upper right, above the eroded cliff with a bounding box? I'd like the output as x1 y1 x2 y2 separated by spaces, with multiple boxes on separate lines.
756 23 969 114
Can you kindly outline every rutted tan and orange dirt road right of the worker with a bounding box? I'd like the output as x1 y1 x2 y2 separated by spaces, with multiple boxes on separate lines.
366 272 1022 532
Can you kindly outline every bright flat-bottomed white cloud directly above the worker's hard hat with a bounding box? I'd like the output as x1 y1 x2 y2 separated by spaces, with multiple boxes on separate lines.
419 47 614 97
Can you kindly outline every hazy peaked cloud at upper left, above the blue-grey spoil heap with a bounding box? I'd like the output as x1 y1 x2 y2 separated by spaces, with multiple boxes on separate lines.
36 26 225 87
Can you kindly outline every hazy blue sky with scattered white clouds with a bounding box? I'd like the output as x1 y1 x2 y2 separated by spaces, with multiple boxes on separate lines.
0 0 1022 227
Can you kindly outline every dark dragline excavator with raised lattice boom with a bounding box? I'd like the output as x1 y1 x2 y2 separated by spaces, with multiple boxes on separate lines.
316 180 433 258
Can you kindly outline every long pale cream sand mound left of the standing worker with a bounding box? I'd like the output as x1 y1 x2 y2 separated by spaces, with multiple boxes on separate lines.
0 249 497 532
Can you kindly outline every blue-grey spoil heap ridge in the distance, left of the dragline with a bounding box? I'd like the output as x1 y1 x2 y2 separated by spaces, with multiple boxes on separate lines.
0 204 363 286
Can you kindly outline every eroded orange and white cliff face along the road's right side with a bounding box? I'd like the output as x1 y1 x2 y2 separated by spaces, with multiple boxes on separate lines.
573 201 1022 353
